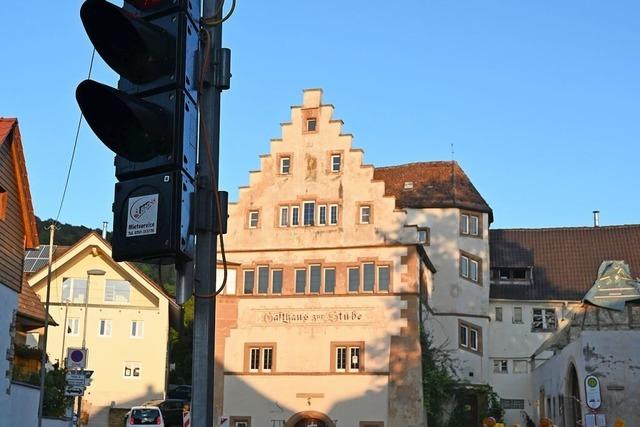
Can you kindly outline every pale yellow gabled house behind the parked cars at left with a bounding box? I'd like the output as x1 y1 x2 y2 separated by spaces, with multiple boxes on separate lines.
28 233 179 427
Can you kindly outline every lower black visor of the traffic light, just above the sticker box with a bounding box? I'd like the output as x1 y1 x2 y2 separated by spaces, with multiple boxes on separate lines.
76 80 171 162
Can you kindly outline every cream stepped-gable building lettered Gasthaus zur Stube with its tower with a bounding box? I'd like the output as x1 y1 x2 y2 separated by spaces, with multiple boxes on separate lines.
216 89 491 427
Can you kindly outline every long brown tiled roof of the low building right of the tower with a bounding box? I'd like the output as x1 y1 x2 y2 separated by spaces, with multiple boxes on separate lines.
489 224 640 300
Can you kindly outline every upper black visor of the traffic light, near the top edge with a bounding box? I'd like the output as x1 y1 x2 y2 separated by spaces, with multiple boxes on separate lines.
80 0 176 84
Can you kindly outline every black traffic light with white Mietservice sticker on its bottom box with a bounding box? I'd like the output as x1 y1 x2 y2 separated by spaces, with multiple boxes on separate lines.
76 0 200 263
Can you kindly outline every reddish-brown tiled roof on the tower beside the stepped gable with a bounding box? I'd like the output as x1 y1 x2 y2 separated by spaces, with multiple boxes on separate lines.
373 161 493 221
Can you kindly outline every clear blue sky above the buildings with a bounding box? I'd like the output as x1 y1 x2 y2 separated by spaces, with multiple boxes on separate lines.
0 0 640 228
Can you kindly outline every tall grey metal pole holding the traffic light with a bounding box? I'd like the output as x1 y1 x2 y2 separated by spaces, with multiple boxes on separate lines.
191 0 222 427
